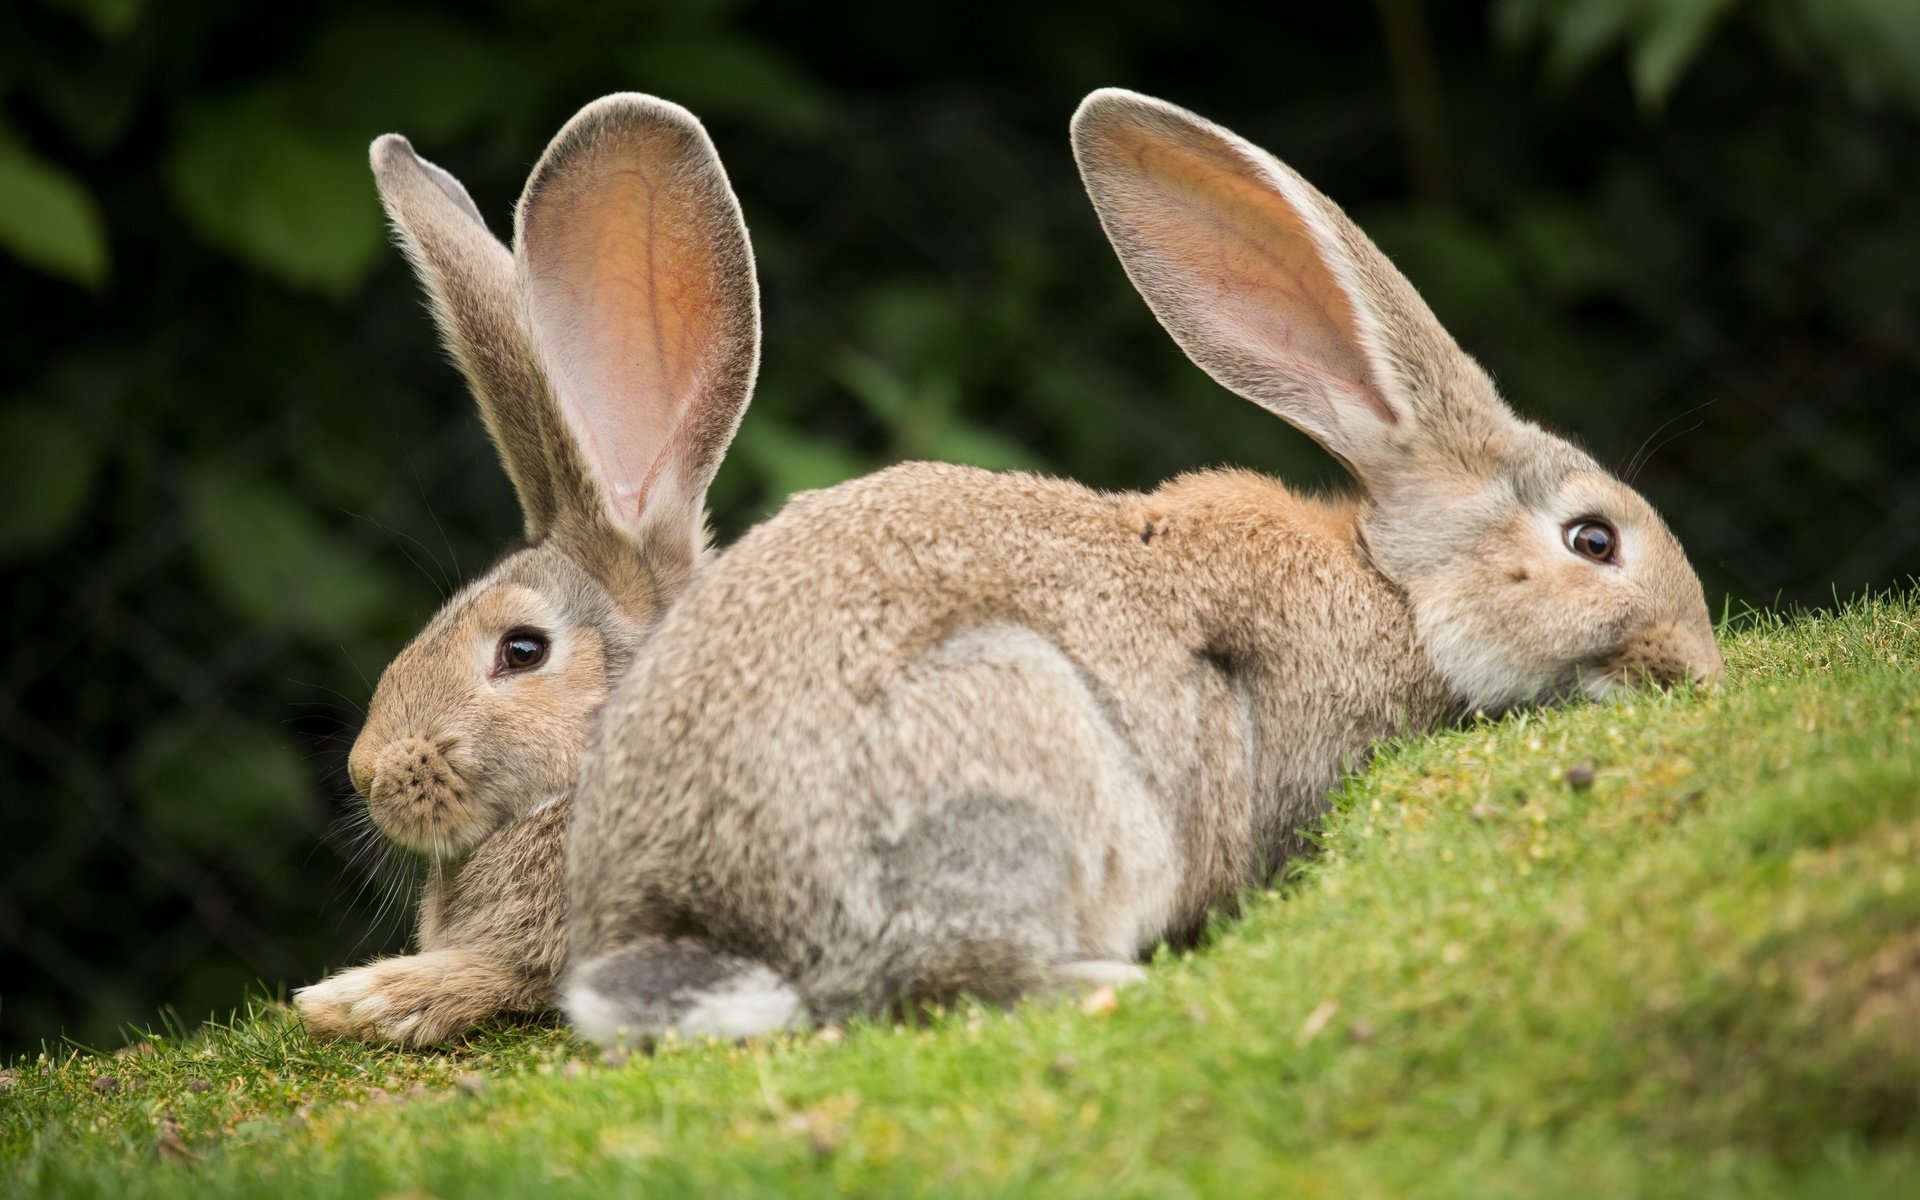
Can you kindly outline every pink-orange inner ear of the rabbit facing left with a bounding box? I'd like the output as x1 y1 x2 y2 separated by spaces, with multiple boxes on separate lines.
522 144 718 526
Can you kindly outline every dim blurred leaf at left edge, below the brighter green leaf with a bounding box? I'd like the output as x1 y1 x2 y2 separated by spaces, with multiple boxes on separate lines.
0 403 100 555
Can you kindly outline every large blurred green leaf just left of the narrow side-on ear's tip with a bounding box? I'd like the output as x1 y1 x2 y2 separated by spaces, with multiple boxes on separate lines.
165 92 384 296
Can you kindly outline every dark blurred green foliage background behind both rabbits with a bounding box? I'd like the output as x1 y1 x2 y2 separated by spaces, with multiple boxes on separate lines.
0 0 1920 1044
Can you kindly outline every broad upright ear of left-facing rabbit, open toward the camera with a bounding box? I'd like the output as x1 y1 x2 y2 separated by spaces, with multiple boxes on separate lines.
515 94 760 568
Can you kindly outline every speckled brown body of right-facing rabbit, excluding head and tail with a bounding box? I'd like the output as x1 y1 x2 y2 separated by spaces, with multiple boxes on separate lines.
568 465 1440 1012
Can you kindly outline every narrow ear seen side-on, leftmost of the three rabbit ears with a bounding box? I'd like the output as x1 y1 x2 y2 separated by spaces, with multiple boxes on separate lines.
369 132 555 541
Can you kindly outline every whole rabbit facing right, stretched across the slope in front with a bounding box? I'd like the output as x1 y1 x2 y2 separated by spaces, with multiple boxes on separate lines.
561 90 1722 1043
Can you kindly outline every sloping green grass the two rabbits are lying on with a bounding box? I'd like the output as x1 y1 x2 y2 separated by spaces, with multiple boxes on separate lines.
0 593 1920 1200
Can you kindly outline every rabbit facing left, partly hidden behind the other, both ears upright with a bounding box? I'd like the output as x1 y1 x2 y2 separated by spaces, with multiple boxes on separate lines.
294 94 760 1044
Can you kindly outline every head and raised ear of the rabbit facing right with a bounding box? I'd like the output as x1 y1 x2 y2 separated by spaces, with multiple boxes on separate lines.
1073 88 1722 710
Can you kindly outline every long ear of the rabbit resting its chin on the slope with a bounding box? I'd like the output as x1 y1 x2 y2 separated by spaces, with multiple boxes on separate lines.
1073 88 1505 486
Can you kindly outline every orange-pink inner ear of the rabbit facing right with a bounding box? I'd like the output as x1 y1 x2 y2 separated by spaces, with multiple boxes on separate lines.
1119 126 1396 422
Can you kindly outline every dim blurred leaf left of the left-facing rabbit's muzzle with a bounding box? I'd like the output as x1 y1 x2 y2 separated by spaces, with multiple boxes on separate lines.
132 718 311 854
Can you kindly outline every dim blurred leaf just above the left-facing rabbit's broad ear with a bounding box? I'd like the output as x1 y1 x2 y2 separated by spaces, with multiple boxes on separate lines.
628 35 831 132
